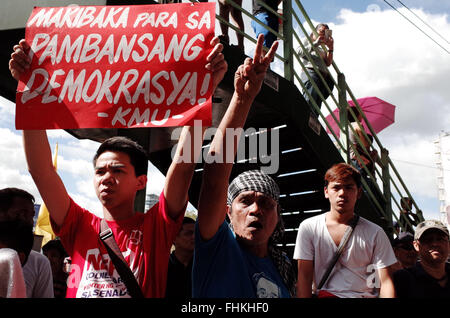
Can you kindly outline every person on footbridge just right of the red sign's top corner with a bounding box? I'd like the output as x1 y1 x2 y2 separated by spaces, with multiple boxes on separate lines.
218 0 244 51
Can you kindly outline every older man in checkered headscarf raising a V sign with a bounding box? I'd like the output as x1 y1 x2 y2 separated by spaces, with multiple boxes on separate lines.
193 35 295 298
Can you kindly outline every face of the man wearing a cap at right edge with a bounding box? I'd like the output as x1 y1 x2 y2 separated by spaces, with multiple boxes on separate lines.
414 229 450 266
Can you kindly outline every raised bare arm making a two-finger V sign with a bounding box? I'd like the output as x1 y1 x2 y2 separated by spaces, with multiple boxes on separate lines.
198 34 278 240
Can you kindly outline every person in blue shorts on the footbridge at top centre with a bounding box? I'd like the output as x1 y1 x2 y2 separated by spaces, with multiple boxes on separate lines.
251 0 282 48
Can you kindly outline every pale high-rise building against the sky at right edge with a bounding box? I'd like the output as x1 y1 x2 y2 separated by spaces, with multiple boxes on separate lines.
434 131 450 227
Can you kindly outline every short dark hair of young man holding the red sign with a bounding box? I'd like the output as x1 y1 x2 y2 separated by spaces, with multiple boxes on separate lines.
93 136 148 176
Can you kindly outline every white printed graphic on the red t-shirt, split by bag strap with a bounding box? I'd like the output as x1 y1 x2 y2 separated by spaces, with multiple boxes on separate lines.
76 230 142 298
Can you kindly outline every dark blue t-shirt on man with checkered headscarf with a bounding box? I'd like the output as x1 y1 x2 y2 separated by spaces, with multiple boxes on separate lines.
192 221 290 298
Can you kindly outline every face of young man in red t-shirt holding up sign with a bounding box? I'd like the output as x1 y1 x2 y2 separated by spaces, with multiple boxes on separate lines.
94 151 147 209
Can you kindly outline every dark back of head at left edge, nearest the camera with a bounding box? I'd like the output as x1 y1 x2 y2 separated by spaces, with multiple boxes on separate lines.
0 219 34 266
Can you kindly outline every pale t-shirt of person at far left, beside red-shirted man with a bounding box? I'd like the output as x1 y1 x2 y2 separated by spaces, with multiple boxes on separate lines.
23 250 54 298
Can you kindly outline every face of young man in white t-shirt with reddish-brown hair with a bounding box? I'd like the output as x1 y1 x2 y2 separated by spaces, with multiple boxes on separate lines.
324 178 361 213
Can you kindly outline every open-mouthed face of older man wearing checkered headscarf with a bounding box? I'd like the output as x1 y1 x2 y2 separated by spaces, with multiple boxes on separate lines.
228 191 278 245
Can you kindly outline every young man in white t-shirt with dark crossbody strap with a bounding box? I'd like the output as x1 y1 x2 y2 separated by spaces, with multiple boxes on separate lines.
294 163 397 298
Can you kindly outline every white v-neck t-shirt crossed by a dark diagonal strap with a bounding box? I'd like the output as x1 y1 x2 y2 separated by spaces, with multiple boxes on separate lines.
294 213 397 298
